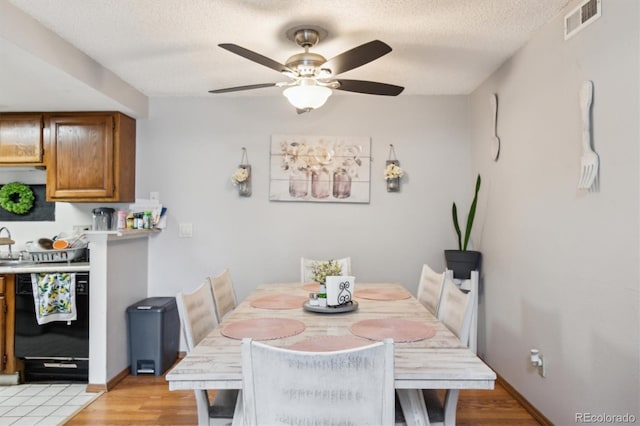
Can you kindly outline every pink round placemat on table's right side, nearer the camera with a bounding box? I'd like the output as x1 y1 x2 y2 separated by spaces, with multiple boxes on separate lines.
349 318 436 343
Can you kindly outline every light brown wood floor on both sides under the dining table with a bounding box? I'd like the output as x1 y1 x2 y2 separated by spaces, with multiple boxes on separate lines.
66 375 539 426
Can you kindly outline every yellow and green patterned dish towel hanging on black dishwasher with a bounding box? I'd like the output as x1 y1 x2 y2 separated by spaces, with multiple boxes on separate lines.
31 272 77 324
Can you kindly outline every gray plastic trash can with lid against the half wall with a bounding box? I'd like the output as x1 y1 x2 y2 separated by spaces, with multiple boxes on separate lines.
127 297 180 376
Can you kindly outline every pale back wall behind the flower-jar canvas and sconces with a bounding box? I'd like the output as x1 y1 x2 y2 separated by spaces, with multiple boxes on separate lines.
137 94 472 299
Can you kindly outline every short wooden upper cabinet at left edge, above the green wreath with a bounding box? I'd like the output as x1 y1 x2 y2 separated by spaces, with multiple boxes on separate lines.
0 113 44 166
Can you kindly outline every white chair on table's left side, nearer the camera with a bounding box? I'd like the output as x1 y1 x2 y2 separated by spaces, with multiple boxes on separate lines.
176 281 238 426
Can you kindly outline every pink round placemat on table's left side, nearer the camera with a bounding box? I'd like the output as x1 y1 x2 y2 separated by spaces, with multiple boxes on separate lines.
220 318 305 340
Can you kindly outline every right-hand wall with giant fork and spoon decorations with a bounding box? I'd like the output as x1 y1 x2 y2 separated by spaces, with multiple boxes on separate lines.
471 0 640 425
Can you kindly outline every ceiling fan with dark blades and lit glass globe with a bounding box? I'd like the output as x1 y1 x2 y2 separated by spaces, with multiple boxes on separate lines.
209 26 404 113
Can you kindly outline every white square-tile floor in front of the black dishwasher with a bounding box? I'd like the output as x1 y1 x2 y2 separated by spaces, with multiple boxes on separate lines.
0 384 99 426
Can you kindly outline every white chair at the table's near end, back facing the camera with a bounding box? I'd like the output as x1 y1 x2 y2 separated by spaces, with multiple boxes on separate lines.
234 338 395 426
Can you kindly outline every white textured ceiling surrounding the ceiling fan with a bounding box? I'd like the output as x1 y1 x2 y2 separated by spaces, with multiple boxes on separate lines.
0 0 568 115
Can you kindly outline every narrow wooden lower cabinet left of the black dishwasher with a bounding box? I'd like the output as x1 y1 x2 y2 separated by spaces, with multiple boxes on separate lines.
0 274 17 374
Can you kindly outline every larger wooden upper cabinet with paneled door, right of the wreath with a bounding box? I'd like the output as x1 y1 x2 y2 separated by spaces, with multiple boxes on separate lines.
45 112 136 202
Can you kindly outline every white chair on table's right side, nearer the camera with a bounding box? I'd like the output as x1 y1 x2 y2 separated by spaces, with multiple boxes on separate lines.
397 274 477 426
